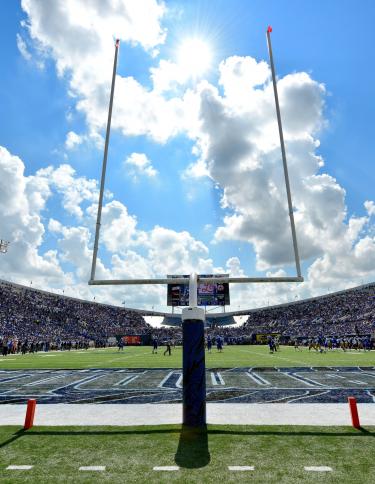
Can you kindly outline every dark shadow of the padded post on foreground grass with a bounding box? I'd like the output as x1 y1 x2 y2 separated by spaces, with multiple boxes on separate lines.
175 425 211 469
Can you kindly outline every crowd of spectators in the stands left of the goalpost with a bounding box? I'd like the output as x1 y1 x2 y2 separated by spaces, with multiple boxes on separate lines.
0 282 151 352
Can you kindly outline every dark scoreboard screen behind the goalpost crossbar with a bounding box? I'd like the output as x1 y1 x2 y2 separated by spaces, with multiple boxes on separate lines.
167 274 230 306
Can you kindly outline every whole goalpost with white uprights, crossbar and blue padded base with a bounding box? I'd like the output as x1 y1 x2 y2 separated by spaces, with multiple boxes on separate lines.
88 27 303 427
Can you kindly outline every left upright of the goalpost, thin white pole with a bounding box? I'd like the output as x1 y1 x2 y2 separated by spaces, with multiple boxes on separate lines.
90 39 120 280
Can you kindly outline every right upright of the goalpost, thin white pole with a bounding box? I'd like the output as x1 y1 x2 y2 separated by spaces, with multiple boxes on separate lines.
267 27 301 277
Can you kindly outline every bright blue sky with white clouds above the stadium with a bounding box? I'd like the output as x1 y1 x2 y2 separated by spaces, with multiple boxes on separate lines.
0 0 375 310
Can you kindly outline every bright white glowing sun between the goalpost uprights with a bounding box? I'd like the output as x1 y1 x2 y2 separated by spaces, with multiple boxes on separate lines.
177 37 212 79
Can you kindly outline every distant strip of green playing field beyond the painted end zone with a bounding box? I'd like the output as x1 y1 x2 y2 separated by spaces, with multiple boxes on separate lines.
0 345 375 370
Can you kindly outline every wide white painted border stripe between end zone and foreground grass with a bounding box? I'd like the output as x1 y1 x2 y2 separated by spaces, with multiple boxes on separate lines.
0 403 375 427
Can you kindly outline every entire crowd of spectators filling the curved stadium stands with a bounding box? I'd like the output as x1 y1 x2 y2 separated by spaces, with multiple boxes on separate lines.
0 282 375 354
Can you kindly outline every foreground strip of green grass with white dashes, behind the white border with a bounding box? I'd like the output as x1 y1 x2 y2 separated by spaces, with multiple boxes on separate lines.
0 425 375 483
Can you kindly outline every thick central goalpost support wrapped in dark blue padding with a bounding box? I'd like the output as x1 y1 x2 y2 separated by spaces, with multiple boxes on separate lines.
182 273 206 427
